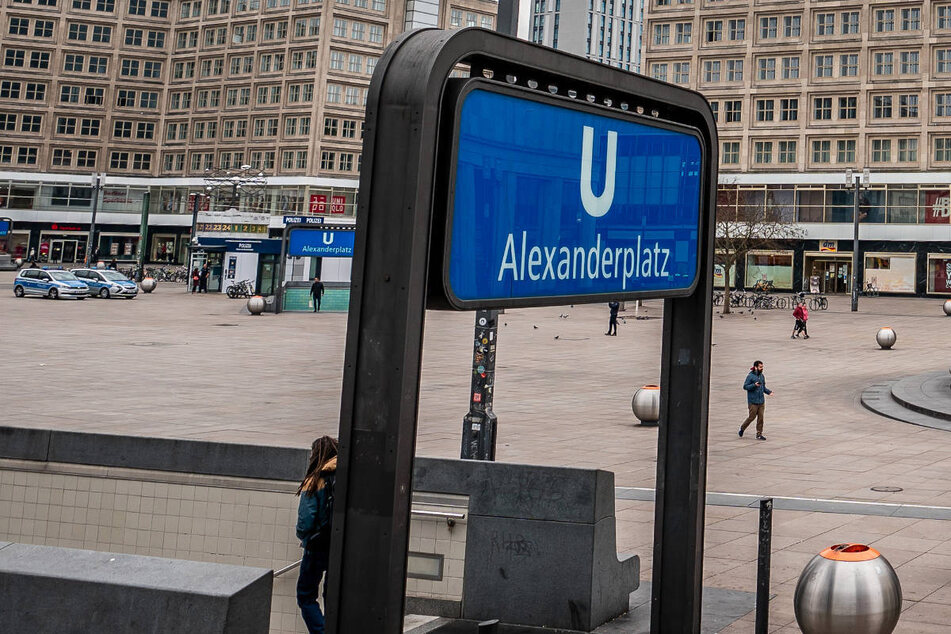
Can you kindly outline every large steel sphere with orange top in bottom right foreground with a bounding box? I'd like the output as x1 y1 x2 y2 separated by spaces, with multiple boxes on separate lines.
793 544 901 634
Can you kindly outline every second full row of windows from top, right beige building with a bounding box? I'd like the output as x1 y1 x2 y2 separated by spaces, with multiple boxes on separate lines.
650 48 951 84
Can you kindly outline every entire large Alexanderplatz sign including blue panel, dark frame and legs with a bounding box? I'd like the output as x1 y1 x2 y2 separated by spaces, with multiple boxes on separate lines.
327 29 717 634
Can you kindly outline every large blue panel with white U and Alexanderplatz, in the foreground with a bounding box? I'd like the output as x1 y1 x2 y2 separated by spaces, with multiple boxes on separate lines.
443 82 704 308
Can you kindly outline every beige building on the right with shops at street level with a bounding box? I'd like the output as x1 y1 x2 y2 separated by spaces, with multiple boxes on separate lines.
645 0 951 294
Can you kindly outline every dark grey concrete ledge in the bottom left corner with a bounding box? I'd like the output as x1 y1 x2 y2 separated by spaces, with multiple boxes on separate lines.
0 544 273 634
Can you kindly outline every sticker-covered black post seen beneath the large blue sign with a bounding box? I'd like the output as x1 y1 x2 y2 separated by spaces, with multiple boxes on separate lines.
460 310 499 460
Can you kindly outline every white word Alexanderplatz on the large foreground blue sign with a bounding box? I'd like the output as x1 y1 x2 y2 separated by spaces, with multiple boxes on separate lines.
498 231 670 290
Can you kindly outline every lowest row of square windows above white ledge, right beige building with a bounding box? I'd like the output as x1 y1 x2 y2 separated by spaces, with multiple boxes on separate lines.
720 137 951 168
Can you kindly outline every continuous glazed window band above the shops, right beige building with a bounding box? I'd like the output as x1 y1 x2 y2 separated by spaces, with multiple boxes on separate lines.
717 184 951 225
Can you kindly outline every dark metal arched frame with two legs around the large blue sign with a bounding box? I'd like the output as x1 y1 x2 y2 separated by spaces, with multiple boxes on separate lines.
327 29 717 634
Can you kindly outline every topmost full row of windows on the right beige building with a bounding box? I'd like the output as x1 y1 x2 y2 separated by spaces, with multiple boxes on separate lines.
651 5 951 46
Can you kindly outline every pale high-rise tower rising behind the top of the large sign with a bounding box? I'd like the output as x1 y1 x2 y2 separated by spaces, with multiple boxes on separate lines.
529 0 644 72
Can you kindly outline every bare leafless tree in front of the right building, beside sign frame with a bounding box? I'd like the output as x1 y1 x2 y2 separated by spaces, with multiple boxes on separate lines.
716 186 802 314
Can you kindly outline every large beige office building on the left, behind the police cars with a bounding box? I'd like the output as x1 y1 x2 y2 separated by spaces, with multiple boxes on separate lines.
0 0 498 264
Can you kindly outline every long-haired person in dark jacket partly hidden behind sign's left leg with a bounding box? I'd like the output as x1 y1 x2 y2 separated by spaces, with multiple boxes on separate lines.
297 436 337 634
